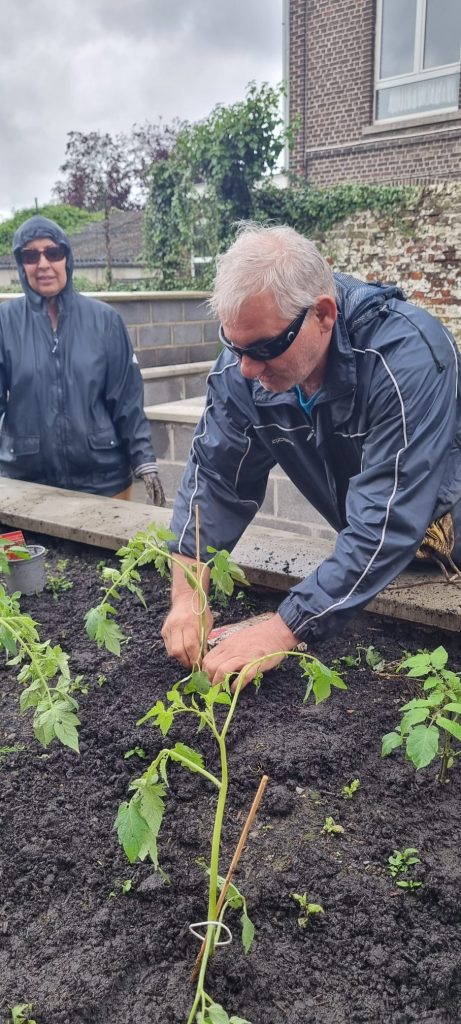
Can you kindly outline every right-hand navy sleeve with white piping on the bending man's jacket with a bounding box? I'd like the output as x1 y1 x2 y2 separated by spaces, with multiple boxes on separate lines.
279 321 458 642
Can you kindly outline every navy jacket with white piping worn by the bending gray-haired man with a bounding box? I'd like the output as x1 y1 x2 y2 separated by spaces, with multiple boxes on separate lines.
172 274 461 641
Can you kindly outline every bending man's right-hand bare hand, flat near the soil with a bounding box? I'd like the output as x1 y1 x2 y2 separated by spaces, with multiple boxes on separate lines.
202 612 299 689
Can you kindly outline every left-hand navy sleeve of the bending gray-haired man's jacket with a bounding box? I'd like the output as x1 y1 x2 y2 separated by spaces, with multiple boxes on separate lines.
171 353 276 560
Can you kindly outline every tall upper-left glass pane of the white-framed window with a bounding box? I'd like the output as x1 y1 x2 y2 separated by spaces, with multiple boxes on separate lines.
379 0 415 78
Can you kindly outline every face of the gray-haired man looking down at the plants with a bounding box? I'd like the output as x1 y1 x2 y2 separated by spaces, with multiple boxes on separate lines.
222 293 336 392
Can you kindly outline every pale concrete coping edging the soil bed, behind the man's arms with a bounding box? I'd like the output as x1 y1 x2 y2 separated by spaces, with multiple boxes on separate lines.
0 478 461 632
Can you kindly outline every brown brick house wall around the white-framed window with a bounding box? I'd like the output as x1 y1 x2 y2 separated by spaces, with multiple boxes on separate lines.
289 0 461 185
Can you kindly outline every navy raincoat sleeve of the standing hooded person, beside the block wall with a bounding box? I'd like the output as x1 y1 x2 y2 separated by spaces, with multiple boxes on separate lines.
106 310 157 476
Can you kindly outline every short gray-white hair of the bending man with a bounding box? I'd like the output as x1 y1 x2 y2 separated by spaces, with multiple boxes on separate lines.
209 221 335 322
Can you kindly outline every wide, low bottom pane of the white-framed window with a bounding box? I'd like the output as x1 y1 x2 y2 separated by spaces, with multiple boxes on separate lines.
376 75 459 121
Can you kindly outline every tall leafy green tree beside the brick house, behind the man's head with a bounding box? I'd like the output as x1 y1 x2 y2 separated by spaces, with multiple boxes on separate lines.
145 82 291 288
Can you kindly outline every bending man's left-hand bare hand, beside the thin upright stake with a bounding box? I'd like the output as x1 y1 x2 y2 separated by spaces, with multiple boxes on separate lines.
162 588 213 669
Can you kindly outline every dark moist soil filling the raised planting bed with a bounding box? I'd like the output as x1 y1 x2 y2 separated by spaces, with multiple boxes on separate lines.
0 535 461 1024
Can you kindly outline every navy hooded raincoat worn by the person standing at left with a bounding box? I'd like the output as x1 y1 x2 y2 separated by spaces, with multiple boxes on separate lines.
0 216 157 495
